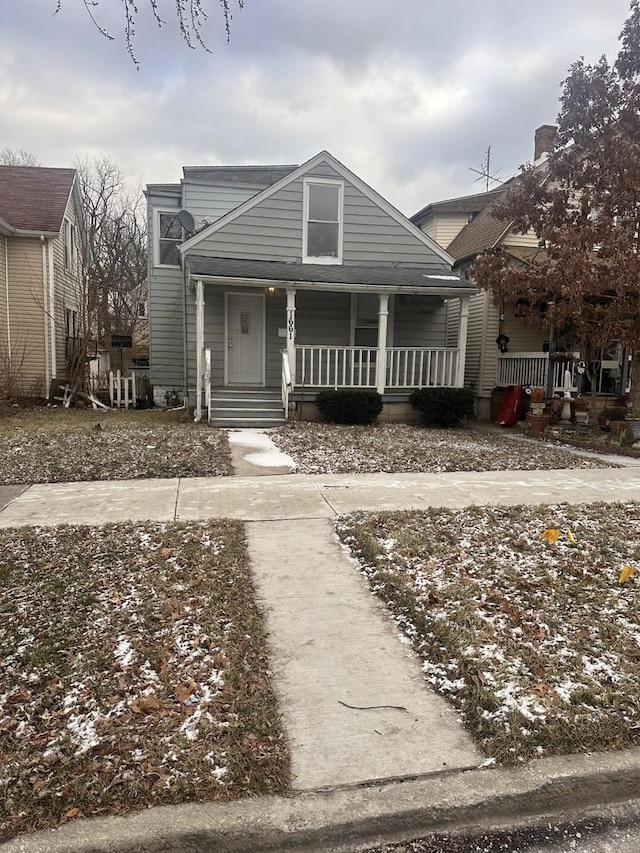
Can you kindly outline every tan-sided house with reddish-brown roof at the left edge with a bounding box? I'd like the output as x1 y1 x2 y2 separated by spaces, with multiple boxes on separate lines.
0 166 82 397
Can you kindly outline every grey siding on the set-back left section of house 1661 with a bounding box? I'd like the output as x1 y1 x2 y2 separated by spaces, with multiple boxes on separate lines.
147 190 184 389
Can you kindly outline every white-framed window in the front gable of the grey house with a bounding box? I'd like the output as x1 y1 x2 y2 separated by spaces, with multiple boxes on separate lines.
302 179 344 264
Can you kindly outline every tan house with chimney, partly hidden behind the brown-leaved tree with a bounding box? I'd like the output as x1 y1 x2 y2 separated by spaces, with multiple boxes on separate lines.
411 125 627 418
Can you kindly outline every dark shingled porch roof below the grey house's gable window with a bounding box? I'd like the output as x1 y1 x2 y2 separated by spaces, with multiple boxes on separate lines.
186 255 476 296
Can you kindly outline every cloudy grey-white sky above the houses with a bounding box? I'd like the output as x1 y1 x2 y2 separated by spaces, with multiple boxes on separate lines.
0 0 629 215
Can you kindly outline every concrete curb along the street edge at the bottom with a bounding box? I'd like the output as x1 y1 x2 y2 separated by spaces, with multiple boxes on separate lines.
5 749 640 853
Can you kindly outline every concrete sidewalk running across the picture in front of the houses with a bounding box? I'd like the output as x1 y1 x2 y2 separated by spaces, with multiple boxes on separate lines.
0 467 640 527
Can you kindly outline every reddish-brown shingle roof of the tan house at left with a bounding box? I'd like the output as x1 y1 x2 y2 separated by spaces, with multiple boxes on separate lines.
0 166 76 233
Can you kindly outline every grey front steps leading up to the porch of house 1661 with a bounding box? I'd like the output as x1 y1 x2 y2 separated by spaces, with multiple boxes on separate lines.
209 388 285 429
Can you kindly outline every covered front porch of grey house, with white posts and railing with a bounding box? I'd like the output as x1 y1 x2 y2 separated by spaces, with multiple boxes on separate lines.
186 265 471 421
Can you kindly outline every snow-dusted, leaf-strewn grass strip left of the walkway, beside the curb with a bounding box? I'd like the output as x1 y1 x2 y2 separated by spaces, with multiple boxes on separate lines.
0 521 289 841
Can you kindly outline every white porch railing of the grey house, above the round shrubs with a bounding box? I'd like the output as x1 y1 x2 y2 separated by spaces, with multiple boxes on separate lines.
295 346 459 389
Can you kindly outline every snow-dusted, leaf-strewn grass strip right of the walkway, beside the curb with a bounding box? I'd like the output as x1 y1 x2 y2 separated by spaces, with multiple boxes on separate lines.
337 503 640 764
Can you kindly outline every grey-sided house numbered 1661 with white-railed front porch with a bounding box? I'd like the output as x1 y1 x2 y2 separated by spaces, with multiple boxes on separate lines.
146 151 475 426
